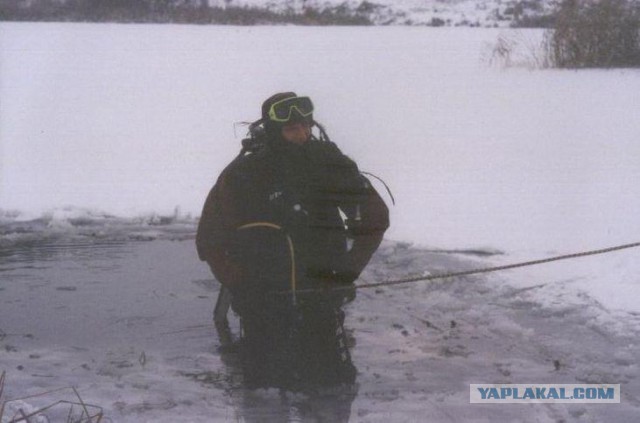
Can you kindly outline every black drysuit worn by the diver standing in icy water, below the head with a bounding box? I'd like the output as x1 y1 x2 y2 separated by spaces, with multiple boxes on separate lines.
196 139 389 388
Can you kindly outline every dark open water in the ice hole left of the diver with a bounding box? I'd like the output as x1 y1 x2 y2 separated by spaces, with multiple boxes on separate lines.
0 224 357 422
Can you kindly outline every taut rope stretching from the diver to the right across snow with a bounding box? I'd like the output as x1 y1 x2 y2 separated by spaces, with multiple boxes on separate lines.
298 242 640 294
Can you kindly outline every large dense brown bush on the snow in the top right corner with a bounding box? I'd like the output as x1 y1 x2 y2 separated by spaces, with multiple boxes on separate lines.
546 0 640 68
